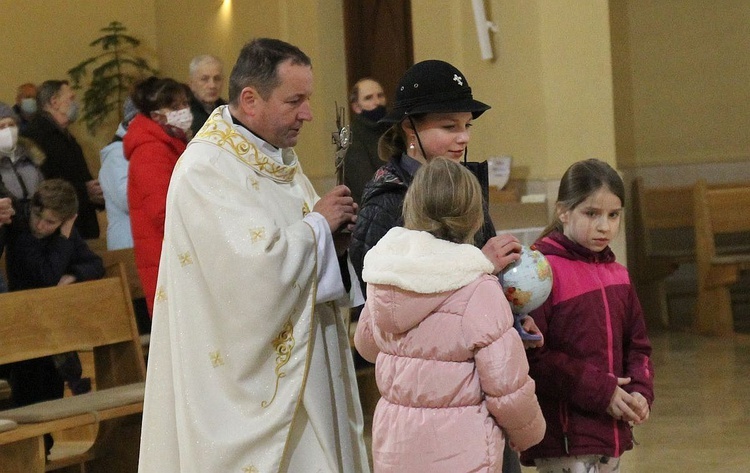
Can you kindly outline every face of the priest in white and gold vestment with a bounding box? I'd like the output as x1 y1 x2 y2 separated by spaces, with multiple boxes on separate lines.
252 61 313 148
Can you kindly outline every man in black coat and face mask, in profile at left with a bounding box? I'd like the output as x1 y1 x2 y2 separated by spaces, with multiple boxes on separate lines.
21 80 104 239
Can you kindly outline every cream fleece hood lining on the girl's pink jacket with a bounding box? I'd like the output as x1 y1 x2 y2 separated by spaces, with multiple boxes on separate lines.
362 227 494 294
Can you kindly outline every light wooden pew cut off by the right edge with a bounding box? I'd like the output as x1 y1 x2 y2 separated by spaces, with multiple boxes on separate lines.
693 180 750 335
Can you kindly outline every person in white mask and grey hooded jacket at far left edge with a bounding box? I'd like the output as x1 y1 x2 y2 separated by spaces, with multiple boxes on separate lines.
0 102 44 215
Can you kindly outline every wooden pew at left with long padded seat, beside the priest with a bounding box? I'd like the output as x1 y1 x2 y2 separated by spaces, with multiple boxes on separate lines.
0 263 146 473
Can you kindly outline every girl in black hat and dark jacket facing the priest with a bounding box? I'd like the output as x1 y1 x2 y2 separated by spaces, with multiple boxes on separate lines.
349 60 543 473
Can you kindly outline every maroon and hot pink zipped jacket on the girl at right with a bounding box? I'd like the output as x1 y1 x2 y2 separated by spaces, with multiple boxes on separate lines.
521 232 654 466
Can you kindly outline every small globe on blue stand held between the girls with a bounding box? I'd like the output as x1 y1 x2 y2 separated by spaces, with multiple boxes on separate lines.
498 246 552 340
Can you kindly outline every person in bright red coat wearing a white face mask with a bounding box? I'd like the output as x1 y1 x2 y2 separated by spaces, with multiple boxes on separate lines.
123 76 193 315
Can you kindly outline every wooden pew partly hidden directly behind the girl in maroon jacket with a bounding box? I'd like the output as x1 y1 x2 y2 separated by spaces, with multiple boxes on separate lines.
631 178 695 327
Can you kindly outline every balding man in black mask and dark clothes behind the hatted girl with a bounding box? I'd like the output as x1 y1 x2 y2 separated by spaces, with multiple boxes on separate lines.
344 77 388 205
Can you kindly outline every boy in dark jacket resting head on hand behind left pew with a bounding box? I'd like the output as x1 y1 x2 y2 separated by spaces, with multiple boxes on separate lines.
7 179 104 452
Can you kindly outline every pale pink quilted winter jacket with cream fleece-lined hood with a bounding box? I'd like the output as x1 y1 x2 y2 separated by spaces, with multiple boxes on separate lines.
354 227 545 473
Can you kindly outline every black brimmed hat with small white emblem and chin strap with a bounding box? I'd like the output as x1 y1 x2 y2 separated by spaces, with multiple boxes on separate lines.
380 59 490 123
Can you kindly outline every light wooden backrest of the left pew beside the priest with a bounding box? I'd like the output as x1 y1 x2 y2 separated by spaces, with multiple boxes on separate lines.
0 266 146 388
